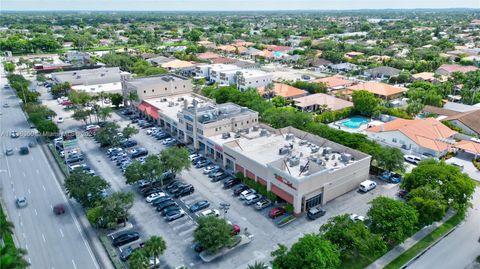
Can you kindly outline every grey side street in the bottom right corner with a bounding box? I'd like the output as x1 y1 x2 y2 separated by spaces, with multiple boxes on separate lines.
408 187 480 269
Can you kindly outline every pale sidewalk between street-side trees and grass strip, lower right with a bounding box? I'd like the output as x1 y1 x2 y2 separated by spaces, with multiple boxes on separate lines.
366 210 455 269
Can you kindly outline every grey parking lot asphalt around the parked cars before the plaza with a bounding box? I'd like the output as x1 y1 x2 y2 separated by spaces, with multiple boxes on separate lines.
41 90 398 268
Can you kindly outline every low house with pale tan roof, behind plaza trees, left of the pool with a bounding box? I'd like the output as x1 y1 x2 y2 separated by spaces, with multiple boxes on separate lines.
293 93 353 112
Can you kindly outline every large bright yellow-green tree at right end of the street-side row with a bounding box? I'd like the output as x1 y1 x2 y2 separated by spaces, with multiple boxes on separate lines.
400 159 475 209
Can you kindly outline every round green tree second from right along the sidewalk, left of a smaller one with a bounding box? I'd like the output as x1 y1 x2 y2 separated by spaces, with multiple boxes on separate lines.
367 197 418 246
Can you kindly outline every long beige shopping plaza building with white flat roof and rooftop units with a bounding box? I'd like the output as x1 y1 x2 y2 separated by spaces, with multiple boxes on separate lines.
126 74 371 213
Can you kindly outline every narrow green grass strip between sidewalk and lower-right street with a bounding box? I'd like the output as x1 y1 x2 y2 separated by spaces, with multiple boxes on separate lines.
385 212 465 269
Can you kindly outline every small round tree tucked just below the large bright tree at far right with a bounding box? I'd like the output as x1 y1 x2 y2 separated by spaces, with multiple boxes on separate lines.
408 185 448 227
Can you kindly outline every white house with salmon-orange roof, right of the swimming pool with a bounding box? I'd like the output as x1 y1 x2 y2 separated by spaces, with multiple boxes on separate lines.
366 118 457 157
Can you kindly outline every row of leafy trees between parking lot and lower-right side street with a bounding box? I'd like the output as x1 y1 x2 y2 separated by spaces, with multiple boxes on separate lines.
272 159 475 269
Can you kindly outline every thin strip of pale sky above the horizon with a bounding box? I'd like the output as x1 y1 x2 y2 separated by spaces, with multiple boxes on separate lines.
0 0 480 10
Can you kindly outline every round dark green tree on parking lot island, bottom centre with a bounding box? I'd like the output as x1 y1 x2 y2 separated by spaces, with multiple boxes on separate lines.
193 216 232 253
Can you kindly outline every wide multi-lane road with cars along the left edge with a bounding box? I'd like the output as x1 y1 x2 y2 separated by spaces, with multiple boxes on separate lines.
0 71 100 269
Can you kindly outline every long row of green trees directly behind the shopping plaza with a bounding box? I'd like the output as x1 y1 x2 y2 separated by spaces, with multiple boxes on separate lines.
202 86 403 171
